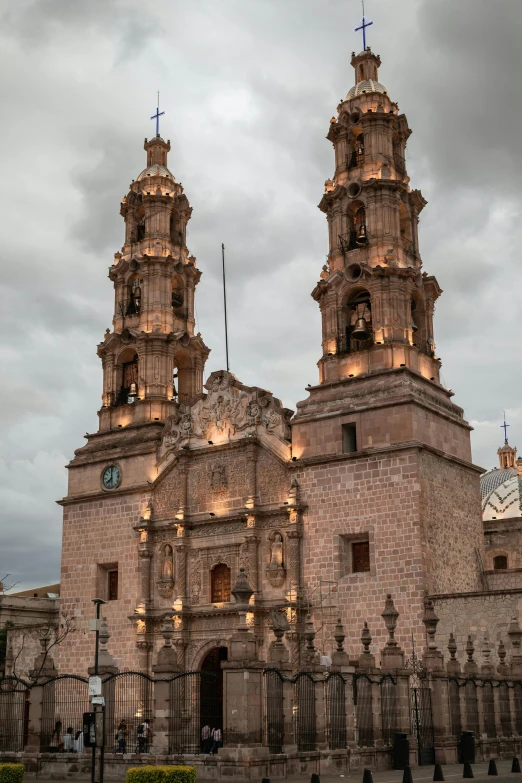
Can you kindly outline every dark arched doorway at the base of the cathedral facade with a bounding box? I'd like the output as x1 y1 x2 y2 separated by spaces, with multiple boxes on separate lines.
199 647 228 753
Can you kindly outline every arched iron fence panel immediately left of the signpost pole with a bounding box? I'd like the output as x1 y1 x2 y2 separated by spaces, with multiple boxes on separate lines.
40 674 91 753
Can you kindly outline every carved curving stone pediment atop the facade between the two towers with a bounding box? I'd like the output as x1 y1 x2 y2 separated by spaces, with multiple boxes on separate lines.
159 370 293 460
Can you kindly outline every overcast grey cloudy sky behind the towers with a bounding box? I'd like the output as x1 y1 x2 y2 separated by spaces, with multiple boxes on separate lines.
0 0 522 589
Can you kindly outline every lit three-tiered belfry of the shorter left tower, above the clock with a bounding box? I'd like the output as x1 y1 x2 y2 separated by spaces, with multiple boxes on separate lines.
98 136 209 431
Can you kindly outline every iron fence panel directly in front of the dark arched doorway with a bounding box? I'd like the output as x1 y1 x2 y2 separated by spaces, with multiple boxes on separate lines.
169 671 223 753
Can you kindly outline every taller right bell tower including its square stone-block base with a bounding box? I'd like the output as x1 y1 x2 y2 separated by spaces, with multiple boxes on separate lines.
292 48 484 656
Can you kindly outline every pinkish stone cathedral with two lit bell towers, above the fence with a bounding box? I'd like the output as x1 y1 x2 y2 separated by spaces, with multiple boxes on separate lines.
43 48 486 673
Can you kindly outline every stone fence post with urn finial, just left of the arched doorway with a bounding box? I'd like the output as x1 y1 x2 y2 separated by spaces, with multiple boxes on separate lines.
152 615 182 753
